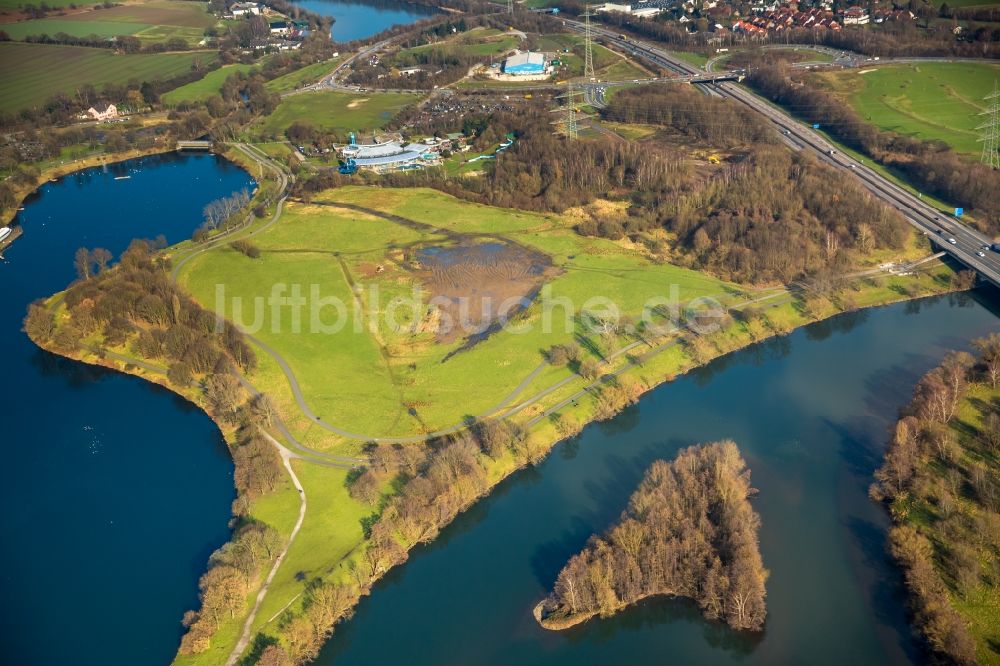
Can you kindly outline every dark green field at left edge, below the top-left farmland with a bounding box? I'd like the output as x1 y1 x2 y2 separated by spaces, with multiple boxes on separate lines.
0 42 218 111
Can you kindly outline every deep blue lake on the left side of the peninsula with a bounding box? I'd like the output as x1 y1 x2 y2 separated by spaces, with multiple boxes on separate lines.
0 154 253 666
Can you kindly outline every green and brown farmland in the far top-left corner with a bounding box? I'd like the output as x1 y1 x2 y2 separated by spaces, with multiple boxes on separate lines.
3 0 217 44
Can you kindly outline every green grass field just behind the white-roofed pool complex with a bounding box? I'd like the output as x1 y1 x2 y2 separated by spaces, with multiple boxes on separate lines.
257 91 420 136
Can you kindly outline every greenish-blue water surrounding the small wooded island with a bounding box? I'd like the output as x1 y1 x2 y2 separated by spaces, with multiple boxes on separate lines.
317 289 1000 666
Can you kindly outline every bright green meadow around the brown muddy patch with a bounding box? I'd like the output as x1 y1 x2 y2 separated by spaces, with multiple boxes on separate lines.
181 187 738 441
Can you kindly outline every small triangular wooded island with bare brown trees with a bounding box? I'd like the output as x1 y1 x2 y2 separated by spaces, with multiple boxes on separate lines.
534 440 768 631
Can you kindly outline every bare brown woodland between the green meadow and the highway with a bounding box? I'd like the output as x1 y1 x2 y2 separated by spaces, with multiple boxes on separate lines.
295 87 909 283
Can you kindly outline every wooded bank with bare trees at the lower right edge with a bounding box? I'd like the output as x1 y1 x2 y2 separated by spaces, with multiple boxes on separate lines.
871 333 1000 664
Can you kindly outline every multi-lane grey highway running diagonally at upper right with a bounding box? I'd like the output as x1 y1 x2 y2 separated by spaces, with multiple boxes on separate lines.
565 19 1000 287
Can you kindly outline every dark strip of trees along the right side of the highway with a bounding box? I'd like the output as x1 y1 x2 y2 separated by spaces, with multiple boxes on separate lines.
748 65 1000 235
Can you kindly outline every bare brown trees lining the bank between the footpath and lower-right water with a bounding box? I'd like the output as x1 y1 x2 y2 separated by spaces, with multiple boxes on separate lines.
247 420 544 666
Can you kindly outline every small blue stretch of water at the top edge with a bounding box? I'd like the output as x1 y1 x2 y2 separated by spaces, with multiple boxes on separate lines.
292 0 438 42
